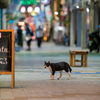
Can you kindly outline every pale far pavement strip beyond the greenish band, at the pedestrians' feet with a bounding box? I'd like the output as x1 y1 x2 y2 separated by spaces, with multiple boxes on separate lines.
16 41 89 53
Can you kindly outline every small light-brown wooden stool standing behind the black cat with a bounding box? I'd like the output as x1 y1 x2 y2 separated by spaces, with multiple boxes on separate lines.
69 50 88 67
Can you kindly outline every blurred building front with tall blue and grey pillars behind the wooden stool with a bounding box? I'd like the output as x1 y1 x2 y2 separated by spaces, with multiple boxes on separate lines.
67 0 100 48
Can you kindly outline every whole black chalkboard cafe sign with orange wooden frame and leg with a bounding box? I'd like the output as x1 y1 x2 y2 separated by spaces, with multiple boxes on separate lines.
0 30 14 88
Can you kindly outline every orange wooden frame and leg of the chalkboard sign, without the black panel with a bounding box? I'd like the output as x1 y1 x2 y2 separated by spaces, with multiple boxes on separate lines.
0 30 15 88
